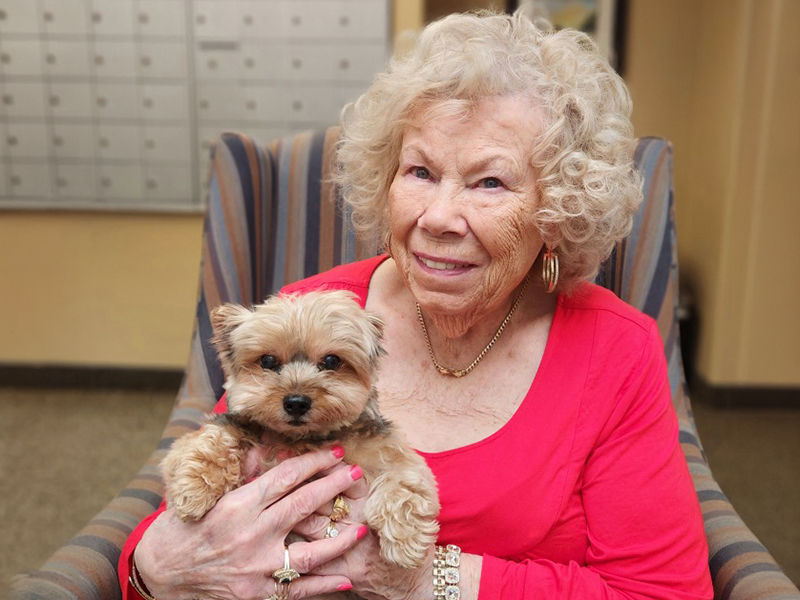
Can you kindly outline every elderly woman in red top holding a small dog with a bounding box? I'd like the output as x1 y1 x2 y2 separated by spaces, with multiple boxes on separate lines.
120 9 712 600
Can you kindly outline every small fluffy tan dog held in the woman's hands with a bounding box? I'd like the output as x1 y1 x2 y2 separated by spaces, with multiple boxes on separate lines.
161 291 439 568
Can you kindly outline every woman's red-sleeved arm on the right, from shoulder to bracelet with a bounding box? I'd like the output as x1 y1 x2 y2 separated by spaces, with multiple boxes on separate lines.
472 325 713 600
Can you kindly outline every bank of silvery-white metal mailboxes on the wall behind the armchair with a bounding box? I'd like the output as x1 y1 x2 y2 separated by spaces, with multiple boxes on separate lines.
0 0 389 210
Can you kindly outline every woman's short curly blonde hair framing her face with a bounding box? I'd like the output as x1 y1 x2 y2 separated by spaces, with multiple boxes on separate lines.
336 11 641 291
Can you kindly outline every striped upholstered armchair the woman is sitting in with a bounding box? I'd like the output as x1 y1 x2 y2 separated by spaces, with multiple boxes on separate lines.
11 127 800 600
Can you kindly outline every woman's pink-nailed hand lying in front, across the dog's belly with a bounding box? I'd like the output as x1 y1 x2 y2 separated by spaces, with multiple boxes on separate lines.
135 448 366 600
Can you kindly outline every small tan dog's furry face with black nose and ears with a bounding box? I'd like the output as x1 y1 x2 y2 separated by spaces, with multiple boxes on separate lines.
211 291 383 439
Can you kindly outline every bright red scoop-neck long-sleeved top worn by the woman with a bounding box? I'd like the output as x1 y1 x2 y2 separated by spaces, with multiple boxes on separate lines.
119 257 713 600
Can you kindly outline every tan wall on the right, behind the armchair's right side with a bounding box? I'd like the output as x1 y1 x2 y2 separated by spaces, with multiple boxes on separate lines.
626 0 800 386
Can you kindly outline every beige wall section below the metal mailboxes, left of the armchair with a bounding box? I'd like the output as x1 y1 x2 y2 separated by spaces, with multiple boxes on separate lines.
0 212 202 368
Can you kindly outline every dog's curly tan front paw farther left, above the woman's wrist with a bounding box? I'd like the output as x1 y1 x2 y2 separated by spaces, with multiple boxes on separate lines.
161 425 242 521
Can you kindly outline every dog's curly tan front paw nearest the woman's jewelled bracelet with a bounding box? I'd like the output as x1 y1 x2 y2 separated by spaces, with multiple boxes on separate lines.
366 473 439 569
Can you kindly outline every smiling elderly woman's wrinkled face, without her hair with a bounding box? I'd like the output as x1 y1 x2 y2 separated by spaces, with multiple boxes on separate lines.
388 96 542 327
